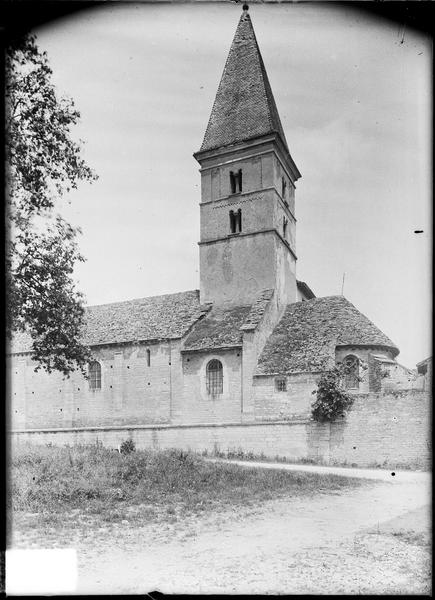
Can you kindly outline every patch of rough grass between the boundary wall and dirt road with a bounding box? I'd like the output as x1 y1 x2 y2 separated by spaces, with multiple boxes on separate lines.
8 445 362 526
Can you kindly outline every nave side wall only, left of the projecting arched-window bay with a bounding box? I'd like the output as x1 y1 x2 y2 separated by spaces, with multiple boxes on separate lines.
7 342 171 429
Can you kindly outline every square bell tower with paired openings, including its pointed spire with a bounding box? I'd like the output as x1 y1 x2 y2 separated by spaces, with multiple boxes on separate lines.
194 4 301 306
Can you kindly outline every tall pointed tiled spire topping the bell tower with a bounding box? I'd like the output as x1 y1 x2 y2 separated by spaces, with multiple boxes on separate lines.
201 4 288 151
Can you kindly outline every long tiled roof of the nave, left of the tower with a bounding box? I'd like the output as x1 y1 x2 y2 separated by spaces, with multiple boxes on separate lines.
6 290 210 352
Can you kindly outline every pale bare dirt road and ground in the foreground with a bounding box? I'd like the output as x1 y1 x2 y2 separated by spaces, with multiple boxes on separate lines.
8 467 431 594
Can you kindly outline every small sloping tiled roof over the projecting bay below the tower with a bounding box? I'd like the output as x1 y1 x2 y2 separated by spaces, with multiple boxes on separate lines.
183 305 251 350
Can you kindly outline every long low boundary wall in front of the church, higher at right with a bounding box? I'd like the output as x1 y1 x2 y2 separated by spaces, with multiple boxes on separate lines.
10 390 432 469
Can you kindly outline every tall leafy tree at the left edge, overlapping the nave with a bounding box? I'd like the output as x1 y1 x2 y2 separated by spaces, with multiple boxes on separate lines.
5 35 96 376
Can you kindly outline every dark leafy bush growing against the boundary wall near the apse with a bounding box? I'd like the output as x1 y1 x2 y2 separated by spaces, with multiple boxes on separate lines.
311 365 353 423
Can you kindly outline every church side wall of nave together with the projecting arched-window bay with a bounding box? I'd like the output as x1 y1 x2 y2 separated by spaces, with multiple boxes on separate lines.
7 340 247 429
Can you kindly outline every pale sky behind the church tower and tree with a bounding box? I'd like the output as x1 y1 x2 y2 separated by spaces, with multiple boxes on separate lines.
31 2 432 367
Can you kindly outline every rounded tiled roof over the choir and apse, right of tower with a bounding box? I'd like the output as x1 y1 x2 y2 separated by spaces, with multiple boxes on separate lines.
256 296 399 375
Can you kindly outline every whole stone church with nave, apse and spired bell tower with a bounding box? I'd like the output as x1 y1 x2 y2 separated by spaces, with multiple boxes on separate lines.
9 6 408 439
